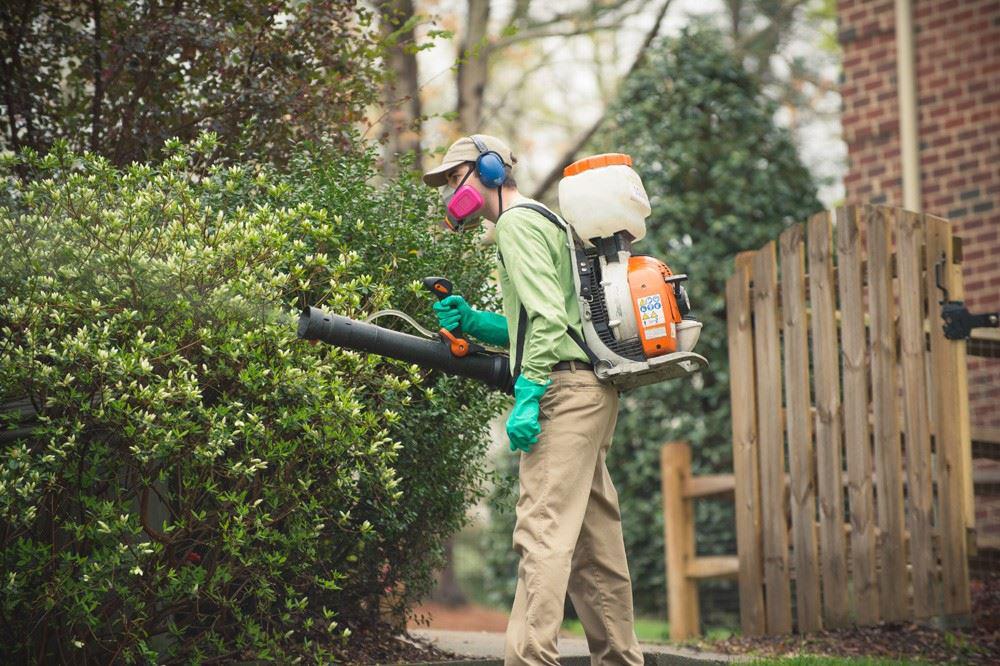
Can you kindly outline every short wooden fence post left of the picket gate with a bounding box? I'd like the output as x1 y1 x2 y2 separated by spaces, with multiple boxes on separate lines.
660 442 699 640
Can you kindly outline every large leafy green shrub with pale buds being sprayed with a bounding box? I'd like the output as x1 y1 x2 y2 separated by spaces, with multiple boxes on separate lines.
0 135 502 663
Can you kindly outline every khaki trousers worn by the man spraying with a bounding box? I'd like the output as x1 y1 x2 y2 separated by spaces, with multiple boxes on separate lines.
504 369 643 666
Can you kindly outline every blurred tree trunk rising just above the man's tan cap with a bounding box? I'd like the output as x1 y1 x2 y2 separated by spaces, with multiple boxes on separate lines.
456 0 490 134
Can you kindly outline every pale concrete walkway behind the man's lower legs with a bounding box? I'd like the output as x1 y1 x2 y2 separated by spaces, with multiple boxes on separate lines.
396 629 738 666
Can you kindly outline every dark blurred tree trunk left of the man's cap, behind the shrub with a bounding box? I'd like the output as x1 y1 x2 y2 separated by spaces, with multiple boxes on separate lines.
379 0 423 175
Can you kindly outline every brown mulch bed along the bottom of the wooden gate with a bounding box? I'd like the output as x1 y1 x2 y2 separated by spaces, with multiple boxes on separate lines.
698 575 1000 664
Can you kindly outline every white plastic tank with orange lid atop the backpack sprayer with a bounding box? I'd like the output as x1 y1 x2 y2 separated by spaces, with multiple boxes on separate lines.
559 153 650 245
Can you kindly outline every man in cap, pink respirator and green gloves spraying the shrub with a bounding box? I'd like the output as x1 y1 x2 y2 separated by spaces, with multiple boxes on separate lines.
423 134 643 665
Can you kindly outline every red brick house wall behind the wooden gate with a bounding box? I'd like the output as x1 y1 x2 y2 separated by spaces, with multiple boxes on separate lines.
837 0 1000 428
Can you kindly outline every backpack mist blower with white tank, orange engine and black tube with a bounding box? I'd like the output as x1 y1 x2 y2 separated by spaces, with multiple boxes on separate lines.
298 153 708 393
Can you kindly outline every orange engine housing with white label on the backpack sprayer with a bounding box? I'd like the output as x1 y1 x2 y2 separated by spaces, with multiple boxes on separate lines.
628 256 681 358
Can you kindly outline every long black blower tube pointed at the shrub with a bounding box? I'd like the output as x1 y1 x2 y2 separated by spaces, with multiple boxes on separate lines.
298 307 514 394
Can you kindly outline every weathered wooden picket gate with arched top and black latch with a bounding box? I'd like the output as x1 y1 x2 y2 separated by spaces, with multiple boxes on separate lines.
726 206 974 635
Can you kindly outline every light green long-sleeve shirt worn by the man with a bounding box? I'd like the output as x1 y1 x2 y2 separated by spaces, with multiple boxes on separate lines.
496 199 588 384
